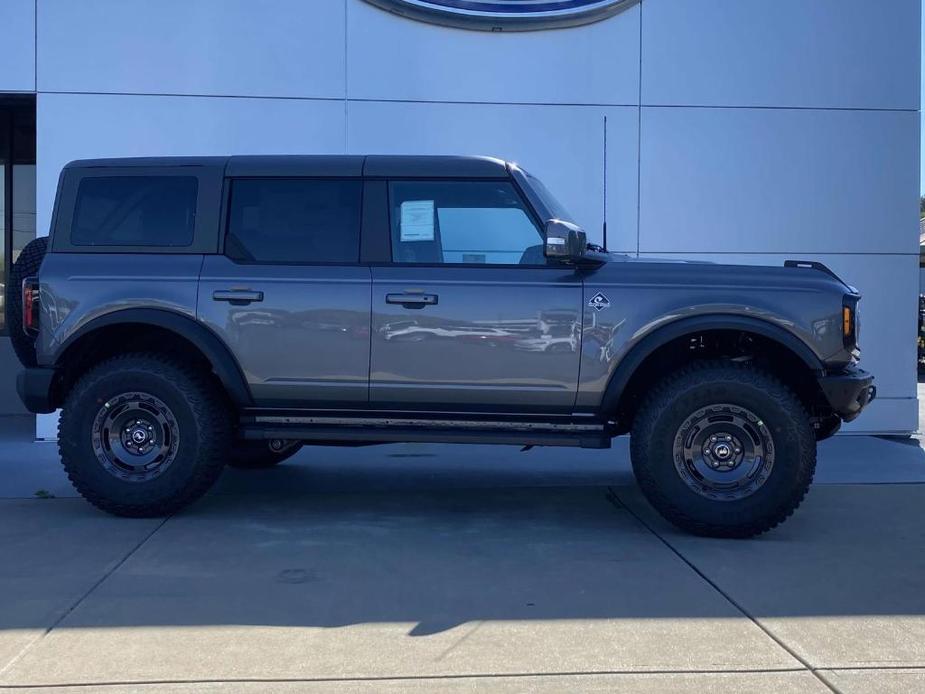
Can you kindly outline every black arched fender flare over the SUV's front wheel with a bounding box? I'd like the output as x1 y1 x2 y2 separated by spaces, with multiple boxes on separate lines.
601 313 825 413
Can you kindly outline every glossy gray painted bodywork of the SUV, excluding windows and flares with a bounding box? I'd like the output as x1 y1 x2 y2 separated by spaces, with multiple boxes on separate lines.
28 157 864 418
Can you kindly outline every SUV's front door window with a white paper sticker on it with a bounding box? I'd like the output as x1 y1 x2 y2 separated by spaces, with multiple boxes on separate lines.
390 181 546 265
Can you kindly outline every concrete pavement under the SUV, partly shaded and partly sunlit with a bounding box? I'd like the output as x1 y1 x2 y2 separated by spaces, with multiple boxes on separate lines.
0 421 925 692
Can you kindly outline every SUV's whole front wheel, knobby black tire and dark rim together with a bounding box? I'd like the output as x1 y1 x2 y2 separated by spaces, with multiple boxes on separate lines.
630 361 816 537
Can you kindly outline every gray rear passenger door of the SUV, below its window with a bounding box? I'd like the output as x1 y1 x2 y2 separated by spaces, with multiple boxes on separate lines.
198 256 370 407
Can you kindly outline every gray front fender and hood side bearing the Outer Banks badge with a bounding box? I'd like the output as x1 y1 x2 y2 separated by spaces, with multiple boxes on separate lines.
576 256 863 409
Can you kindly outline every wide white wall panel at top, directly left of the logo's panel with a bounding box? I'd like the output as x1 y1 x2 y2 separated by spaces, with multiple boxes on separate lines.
38 0 346 98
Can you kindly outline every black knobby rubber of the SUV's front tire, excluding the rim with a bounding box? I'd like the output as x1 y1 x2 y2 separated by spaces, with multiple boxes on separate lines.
630 361 816 538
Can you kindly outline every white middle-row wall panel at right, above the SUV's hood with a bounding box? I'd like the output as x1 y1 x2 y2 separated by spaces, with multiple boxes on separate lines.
640 108 919 254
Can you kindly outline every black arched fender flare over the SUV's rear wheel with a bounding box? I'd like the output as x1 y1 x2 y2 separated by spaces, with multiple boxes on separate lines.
55 308 253 407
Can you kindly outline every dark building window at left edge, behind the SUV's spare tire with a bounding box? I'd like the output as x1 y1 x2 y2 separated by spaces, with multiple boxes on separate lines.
0 97 35 333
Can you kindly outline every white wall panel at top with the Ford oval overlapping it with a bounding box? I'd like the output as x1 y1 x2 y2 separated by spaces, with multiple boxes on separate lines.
347 0 639 105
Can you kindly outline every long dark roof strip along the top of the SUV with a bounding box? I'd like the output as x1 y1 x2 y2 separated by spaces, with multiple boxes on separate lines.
65 154 508 178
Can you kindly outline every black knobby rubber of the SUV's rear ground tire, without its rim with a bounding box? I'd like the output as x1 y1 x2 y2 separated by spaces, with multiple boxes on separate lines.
58 353 232 518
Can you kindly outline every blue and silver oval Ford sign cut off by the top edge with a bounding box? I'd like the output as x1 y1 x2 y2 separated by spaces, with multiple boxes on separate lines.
366 0 639 31
